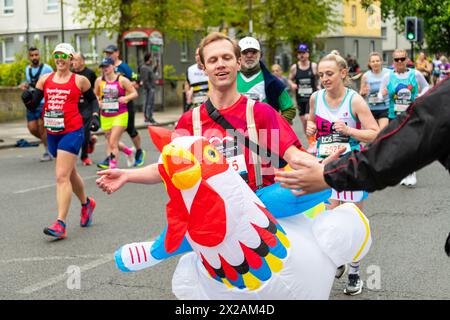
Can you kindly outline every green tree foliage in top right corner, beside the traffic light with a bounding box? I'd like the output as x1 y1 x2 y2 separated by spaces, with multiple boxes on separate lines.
361 0 450 53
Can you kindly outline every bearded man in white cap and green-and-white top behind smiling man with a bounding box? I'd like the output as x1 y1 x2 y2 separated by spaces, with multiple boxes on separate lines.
237 37 296 124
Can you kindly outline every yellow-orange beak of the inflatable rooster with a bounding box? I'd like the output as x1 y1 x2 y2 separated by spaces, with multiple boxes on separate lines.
162 144 201 190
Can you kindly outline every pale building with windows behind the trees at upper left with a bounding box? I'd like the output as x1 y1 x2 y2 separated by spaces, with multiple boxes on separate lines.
0 0 196 74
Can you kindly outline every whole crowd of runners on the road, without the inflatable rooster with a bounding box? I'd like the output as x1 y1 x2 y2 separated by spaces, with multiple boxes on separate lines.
15 33 450 295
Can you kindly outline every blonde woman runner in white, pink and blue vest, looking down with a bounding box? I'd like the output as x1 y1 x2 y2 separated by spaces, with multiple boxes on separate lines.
306 54 380 295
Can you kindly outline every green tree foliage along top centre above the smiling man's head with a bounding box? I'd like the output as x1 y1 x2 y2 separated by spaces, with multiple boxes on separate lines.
77 0 339 62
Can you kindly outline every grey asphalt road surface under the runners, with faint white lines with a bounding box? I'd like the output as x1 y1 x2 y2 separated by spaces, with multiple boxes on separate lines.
0 123 450 300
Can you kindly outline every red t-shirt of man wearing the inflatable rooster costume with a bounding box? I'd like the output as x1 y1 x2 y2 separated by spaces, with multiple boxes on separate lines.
175 95 301 190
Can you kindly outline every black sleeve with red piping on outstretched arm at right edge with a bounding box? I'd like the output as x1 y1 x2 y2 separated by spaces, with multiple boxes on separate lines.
324 78 450 191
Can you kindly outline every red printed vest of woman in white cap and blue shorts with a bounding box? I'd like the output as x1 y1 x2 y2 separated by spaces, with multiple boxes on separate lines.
42 73 83 134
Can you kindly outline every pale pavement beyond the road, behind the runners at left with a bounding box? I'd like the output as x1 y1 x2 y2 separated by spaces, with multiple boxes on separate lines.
0 106 183 149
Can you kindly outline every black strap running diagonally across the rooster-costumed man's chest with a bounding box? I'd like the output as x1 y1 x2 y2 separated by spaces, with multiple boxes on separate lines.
205 99 287 168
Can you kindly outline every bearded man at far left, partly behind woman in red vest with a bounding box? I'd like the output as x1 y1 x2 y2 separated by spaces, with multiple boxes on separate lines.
20 47 53 162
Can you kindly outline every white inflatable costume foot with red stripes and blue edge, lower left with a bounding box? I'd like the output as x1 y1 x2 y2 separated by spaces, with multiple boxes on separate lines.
114 241 161 272
